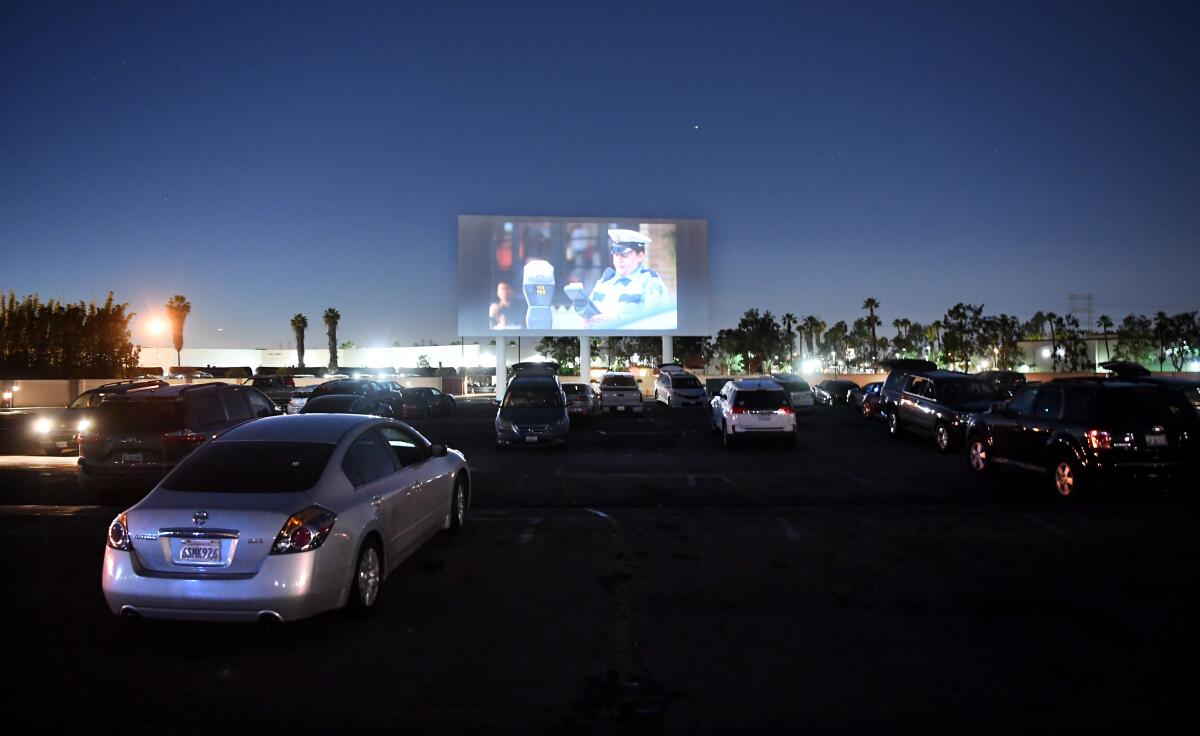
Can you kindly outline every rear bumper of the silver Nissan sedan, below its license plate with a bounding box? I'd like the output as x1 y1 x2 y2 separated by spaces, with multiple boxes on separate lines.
101 546 350 621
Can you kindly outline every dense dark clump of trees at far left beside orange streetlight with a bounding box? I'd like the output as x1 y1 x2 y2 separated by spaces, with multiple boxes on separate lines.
0 292 138 378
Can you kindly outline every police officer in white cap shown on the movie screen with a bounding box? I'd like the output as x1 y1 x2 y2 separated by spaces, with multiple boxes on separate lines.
586 229 667 325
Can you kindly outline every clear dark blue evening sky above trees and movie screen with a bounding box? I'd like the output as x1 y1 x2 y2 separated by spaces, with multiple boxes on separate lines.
0 1 1200 347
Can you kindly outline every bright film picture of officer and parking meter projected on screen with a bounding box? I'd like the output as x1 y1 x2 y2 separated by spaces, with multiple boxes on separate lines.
476 220 678 333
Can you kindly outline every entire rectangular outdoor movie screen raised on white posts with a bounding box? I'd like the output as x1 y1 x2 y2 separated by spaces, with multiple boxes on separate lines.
458 216 708 335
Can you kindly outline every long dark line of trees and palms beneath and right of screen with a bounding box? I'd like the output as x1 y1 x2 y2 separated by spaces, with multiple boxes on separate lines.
538 298 1200 375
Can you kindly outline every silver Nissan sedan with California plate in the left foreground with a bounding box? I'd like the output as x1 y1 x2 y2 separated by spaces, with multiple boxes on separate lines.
101 414 470 621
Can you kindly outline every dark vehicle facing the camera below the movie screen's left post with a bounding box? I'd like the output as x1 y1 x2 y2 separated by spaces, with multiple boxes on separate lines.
496 375 571 448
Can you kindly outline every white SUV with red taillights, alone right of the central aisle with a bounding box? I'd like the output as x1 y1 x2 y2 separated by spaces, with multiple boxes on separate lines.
709 378 796 449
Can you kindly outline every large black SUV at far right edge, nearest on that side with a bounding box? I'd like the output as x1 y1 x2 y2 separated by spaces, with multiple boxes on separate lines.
967 378 1200 498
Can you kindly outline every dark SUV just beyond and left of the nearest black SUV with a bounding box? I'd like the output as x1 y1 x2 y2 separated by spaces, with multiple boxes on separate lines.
888 371 1002 453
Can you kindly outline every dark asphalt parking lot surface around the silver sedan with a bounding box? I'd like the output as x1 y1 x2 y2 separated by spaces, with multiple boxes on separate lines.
0 402 1200 732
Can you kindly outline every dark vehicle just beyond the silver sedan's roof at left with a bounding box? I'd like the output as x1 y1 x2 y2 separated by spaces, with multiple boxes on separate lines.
79 383 280 492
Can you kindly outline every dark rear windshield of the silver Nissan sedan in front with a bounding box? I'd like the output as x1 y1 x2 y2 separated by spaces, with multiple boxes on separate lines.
162 442 336 493
